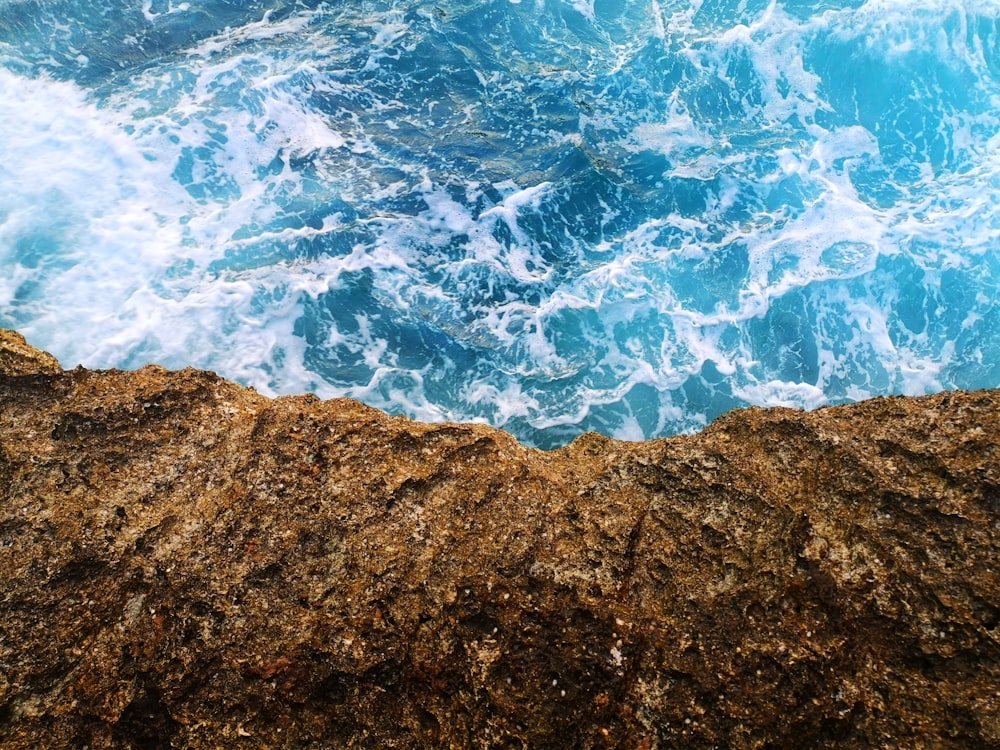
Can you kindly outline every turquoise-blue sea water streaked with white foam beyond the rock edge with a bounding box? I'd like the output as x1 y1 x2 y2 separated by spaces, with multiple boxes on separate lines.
0 0 1000 447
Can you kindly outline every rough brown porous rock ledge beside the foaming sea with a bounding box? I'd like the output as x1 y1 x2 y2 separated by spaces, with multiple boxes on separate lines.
0 332 1000 748
